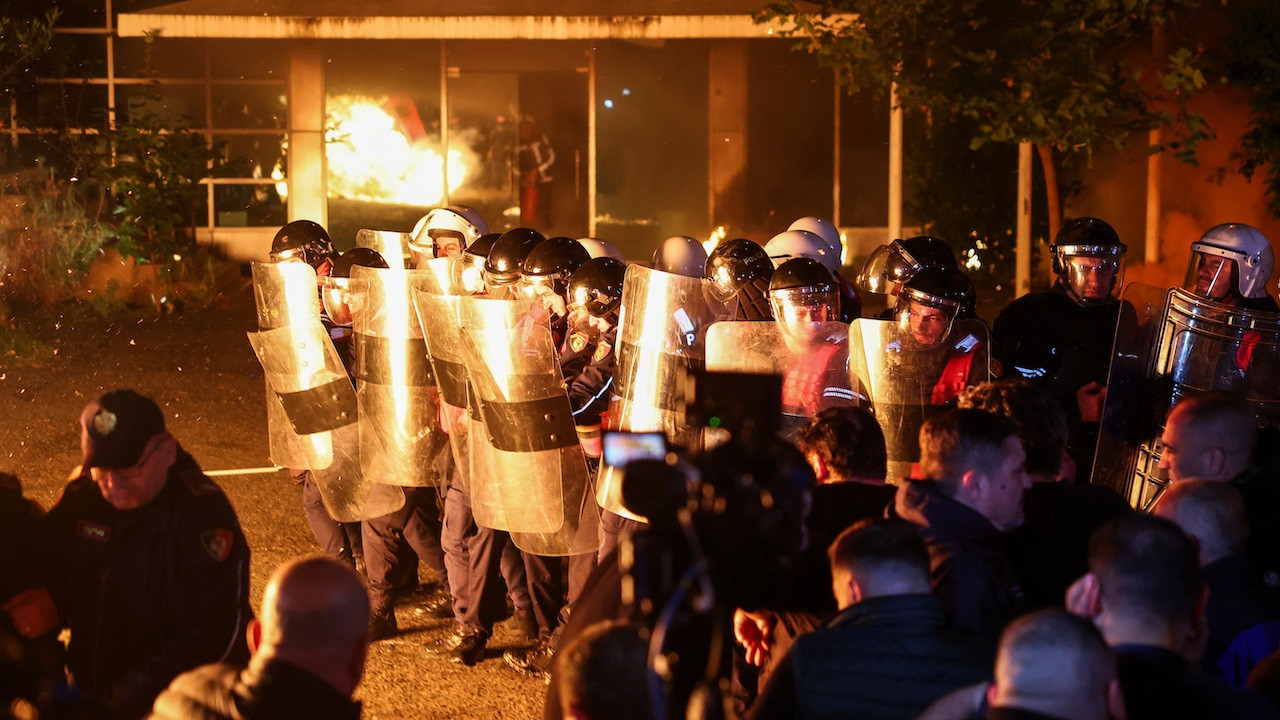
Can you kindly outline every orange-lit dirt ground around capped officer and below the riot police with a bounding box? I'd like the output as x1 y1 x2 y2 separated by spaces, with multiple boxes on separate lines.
0 274 545 720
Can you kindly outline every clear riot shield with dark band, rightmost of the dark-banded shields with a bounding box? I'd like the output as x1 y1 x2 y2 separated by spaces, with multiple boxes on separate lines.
460 297 599 556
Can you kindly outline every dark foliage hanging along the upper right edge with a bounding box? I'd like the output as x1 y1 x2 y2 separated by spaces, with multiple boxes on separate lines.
1228 0 1280 218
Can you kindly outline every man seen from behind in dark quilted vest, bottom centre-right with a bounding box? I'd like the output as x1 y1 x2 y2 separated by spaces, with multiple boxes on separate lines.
750 520 991 720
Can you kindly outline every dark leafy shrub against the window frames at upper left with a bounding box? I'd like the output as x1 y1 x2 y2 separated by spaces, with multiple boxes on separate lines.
84 99 220 263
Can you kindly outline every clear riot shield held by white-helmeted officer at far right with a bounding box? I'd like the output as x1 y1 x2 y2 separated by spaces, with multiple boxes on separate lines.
1093 283 1280 510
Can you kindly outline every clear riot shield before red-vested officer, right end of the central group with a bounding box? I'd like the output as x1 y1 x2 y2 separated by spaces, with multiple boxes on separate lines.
849 318 991 482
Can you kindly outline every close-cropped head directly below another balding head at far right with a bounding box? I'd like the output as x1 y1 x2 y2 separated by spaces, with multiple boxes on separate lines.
1156 480 1249 568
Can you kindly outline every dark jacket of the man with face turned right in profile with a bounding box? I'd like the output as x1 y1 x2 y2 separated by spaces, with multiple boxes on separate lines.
895 480 1024 642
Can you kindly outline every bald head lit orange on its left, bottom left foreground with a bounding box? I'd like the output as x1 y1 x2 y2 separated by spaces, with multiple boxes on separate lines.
255 557 369 693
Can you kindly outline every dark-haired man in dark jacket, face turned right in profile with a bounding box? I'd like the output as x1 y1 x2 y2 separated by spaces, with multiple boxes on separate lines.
895 410 1030 643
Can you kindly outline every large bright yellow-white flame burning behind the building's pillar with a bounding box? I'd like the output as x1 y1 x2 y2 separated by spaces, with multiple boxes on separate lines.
325 95 468 206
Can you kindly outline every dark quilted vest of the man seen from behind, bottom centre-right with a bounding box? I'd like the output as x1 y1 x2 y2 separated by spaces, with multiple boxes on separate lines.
749 594 993 720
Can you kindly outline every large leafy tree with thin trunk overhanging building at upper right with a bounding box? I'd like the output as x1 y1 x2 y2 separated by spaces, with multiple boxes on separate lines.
760 0 1210 237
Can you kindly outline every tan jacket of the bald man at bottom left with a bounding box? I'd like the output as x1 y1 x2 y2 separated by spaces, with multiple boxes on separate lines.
151 660 360 720
